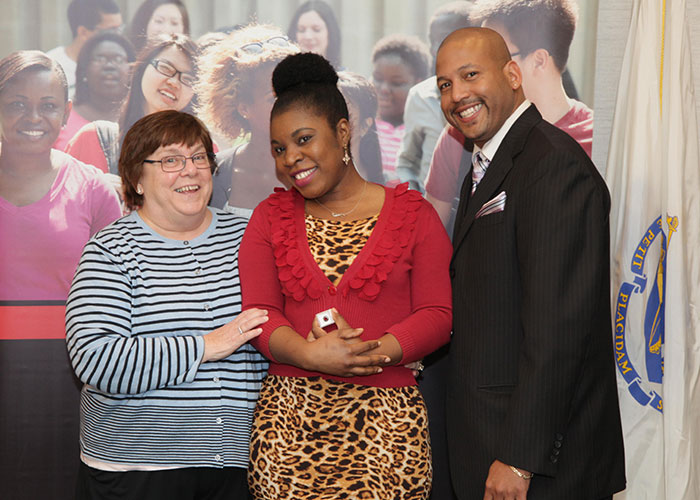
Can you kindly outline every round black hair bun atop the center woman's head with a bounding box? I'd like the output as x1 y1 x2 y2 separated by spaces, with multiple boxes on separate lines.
272 52 338 96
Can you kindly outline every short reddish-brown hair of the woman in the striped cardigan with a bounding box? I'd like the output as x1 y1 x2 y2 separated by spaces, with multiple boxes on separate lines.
119 110 216 210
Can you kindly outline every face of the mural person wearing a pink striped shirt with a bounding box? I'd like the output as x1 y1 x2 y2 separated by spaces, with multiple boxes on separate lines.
372 54 418 125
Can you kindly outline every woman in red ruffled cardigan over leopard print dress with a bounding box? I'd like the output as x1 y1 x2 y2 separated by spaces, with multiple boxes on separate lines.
240 53 452 500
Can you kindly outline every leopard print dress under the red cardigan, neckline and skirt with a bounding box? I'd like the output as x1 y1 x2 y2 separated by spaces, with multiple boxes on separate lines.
248 215 432 500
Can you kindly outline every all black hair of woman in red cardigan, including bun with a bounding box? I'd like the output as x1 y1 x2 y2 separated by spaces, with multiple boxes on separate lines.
271 52 349 130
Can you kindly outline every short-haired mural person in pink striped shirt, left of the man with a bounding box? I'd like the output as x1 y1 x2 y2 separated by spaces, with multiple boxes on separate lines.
372 35 430 185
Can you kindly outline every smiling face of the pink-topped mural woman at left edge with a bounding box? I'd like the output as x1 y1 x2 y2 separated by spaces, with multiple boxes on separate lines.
0 68 70 154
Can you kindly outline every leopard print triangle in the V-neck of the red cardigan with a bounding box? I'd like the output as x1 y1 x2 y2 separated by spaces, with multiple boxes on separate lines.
305 215 379 286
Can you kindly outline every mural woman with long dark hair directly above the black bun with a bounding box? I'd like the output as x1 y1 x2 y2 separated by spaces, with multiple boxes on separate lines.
287 0 341 68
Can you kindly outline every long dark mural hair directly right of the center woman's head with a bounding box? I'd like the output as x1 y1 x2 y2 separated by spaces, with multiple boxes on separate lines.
338 71 384 184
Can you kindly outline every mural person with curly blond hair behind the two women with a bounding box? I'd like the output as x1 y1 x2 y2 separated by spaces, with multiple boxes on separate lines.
197 24 299 211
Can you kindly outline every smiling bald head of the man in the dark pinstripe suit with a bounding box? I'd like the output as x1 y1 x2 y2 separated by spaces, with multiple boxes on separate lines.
436 28 523 147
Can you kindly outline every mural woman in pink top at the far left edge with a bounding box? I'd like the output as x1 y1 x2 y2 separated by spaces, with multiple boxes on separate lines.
0 50 121 301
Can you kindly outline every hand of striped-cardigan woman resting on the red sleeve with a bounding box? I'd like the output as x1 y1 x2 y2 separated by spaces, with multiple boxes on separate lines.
202 309 268 363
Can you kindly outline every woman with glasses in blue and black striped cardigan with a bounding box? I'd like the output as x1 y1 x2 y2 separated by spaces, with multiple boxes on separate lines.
66 111 267 499
